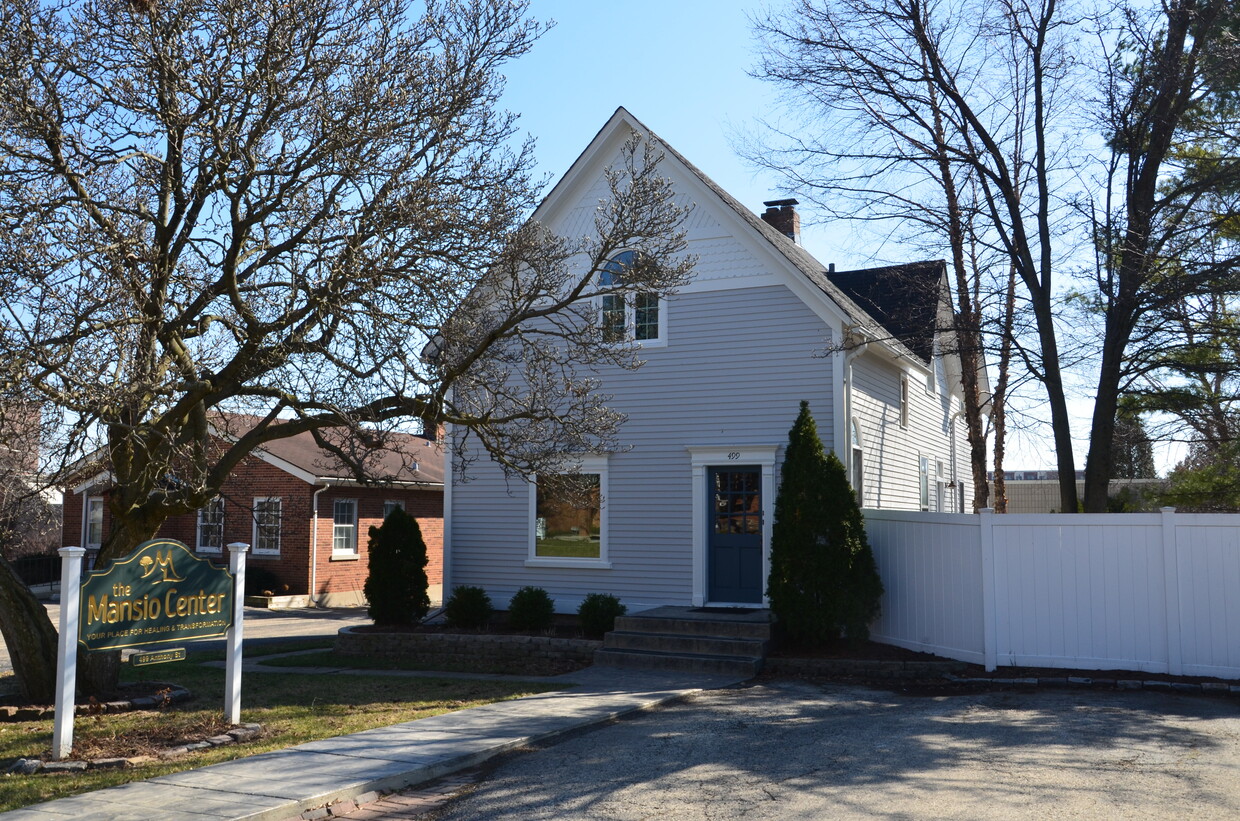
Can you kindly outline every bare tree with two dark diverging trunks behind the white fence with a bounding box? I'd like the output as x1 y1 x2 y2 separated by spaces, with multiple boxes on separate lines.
759 0 1236 511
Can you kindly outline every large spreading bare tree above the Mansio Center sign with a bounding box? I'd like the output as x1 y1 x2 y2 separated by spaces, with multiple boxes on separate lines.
0 0 691 699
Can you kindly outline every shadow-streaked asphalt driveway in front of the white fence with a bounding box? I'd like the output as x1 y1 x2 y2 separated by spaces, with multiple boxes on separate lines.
433 682 1240 821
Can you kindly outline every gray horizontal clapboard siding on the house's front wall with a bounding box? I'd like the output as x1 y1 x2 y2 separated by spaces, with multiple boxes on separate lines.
450 286 833 611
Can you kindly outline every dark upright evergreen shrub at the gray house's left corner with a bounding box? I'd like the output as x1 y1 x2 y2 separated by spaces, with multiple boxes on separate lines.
362 508 430 624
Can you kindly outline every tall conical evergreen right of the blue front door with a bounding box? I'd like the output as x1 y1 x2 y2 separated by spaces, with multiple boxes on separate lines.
766 402 883 642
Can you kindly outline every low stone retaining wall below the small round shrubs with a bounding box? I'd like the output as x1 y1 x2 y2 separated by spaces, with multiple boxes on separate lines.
336 628 603 676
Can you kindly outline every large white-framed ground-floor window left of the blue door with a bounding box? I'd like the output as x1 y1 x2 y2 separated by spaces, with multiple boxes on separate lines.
529 458 608 566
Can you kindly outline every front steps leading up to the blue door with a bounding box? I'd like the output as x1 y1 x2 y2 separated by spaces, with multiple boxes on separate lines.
594 608 771 678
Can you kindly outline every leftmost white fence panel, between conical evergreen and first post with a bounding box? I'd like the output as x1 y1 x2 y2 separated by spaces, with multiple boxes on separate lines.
863 510 985 663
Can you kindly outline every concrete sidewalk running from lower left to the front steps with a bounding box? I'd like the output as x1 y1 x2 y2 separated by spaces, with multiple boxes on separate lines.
0 667 737 821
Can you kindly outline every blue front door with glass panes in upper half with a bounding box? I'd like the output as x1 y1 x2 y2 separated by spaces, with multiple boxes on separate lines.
707 465 764 604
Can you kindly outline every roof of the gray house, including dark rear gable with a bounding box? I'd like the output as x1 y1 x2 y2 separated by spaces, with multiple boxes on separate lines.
553 105 942 365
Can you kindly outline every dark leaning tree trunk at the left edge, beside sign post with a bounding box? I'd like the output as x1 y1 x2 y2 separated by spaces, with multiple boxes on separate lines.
0 557 58 704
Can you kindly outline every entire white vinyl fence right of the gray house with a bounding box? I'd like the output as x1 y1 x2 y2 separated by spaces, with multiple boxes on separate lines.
863 508 1240 678
